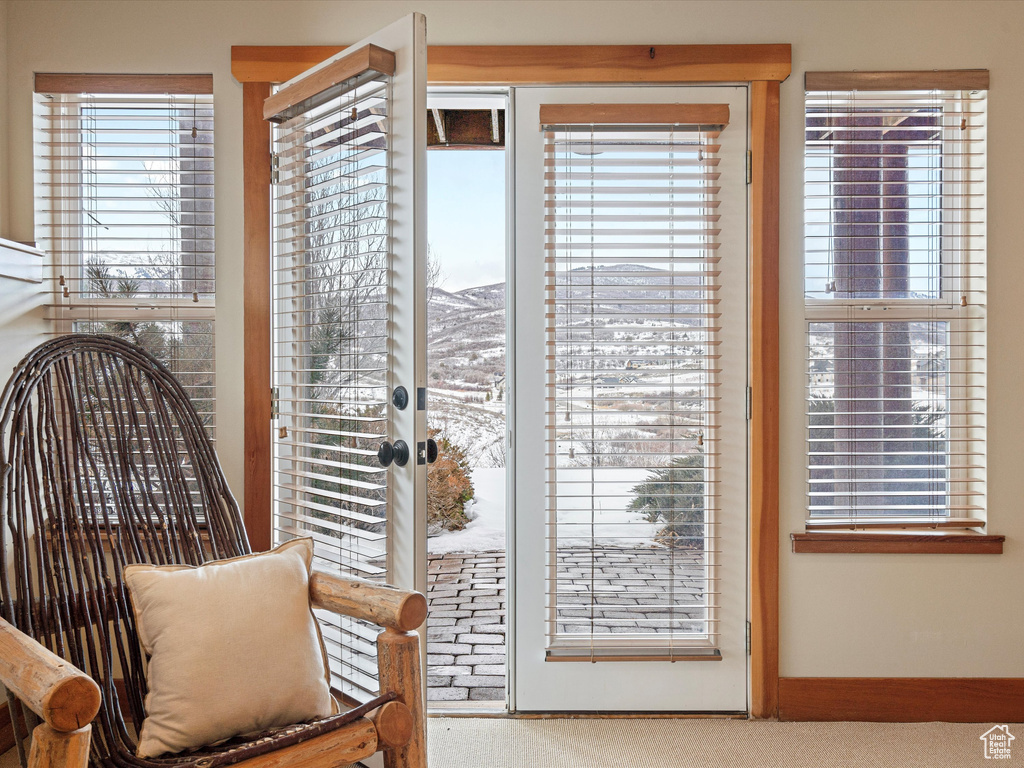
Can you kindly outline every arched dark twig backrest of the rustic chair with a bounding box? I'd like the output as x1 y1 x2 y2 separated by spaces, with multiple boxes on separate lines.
0 334 250 765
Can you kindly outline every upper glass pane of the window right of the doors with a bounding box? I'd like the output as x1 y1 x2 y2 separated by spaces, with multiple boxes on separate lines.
805 98 944 300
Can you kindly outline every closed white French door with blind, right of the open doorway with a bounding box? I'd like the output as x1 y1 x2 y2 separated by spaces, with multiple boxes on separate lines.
511 86 748 712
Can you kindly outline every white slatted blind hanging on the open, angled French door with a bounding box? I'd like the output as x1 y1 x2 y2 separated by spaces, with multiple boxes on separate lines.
272 66 391 700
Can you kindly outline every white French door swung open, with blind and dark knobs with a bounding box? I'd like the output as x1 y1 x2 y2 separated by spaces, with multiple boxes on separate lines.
264 13 427 700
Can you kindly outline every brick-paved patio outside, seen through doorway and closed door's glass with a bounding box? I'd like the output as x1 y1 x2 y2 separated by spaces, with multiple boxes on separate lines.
427 547 708 701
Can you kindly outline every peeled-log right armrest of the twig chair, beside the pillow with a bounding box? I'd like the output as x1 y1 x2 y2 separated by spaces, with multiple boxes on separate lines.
309 570 427 632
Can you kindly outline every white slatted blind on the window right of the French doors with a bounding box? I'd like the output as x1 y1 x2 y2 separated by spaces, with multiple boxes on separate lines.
805 73 987 527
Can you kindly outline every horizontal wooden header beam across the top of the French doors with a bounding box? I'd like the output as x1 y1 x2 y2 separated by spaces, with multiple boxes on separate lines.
231 43 792 85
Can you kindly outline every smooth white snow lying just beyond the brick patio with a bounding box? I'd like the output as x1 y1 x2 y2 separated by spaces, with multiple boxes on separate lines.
427 468 659 554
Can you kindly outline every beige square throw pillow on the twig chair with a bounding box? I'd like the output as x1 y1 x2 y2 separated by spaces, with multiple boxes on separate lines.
125 539 337 758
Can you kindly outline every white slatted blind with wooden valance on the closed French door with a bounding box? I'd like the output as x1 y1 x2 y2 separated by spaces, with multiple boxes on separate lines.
541 104 729 658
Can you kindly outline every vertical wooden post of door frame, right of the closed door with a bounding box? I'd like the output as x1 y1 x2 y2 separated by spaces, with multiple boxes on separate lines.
751 81 779 718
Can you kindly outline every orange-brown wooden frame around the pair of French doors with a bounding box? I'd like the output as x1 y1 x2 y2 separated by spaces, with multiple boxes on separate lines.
231 44 792 718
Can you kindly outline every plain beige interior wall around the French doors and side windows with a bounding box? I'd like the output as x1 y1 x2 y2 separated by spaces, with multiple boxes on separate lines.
6 0 1024 676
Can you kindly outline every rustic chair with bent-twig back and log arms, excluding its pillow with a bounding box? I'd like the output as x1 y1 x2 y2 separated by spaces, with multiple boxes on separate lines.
0 334 426 768
